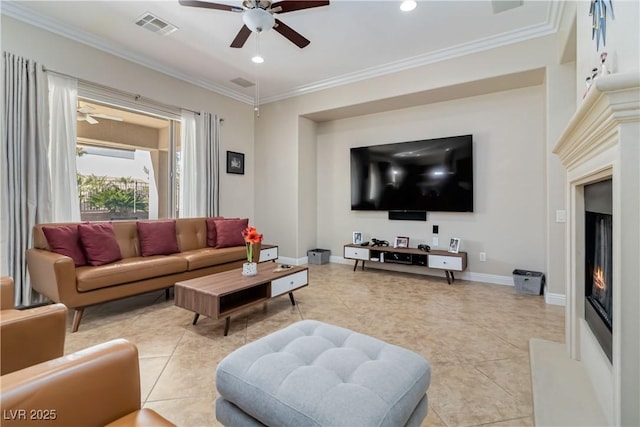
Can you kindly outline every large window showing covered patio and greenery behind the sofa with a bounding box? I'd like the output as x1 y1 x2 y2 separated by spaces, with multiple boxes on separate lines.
76 96 180 221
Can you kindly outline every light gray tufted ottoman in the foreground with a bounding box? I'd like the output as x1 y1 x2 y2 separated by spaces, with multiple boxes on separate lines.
216 320 431 427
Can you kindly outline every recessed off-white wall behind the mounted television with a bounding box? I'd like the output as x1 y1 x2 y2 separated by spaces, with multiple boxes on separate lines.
318 86 546 277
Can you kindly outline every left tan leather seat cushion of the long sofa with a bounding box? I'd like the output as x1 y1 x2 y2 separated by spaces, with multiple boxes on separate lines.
76 255 187 292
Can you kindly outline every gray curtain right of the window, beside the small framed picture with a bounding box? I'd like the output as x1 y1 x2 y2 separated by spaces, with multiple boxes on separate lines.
196 112 220 217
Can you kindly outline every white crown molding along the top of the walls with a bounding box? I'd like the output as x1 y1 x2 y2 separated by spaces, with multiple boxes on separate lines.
0 1 564 105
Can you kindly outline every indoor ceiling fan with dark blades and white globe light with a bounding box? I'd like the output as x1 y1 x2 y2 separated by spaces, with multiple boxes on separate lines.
179 0 329 49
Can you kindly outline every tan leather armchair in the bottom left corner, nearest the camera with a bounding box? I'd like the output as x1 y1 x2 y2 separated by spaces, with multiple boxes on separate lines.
0 339 175 427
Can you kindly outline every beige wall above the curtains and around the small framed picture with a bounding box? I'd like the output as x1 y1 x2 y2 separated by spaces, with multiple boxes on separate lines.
1 15 255 218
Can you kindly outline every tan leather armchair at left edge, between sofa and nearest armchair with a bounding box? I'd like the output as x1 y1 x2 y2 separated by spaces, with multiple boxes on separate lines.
0 277 67 375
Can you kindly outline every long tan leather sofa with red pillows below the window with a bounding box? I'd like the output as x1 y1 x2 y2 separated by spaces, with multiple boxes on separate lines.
27 218 246 332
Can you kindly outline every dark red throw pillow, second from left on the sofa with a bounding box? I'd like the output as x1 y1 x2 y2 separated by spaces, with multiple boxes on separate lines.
78 223 122 265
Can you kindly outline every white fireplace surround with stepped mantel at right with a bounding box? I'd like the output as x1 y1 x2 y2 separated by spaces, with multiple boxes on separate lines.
554 73 640 426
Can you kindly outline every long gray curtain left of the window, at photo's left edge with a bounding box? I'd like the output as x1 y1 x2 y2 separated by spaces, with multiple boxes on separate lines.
0 52 51 306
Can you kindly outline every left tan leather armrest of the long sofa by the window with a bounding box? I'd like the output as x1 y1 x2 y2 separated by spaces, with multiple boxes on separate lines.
27 248 78 308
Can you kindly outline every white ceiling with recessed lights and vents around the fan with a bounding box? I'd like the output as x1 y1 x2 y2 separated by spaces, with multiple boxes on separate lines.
2 0 561 103
